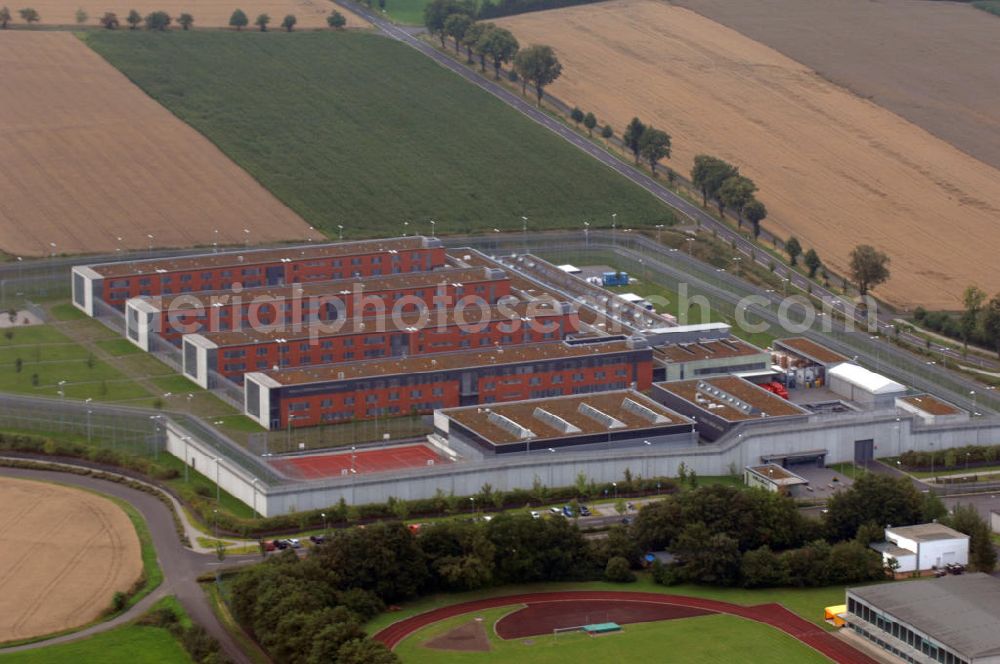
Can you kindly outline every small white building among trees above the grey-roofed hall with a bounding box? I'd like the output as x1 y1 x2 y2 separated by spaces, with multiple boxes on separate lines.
872 523 969 574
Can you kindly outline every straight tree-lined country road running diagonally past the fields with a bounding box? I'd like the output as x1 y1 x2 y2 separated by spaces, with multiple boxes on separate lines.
334 0 997 378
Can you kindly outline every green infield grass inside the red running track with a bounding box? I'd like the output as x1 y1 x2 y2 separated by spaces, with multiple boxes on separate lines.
395 606 828 664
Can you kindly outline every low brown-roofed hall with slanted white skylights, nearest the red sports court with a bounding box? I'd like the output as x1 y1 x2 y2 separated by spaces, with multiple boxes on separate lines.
434 390 697 456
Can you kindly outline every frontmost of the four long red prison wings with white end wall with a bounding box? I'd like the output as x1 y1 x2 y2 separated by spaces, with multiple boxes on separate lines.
244 337 653 429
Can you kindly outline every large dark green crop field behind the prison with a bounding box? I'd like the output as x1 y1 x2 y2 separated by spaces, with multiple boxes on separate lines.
84 31 674 238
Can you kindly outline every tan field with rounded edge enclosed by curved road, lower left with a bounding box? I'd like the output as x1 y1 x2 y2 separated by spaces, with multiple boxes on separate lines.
0 478 142 642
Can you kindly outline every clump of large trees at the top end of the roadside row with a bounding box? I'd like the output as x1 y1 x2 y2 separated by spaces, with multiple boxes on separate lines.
424 0 564 105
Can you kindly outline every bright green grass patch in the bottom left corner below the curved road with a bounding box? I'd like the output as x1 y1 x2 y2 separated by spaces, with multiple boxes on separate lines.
0 596 191 664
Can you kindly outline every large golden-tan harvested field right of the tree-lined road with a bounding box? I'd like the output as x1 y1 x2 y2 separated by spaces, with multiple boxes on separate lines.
499 0 1000 308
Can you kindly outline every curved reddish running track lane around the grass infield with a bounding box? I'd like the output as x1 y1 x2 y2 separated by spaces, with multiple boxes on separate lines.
373 590 878 664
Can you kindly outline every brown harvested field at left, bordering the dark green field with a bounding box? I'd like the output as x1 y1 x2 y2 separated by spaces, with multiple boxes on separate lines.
0 30 319 256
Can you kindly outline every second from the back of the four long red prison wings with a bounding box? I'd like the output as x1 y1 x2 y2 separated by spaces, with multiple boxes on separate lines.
125 268 510 351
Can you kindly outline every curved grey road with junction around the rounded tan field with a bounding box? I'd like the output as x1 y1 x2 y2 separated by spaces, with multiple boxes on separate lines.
0 468 259 663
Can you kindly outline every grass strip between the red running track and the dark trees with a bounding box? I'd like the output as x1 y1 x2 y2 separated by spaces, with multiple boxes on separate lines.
365 573 844 634
